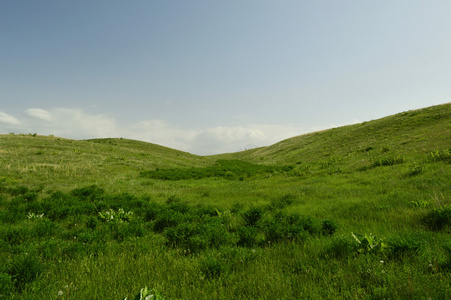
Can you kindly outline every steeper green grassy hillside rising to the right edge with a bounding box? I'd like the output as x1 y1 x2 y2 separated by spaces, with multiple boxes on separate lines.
215 103 451 168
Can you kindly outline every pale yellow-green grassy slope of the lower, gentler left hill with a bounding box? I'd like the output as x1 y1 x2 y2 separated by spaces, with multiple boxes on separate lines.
0 134 209 190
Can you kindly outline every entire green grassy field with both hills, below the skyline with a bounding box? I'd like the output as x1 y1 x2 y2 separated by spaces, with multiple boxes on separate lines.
0 103 451 299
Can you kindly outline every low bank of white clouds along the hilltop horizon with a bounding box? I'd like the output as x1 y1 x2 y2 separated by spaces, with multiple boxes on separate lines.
0 108 356 155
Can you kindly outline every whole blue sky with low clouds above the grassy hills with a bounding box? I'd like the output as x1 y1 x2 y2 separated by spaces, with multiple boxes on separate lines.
0 0 451 155
